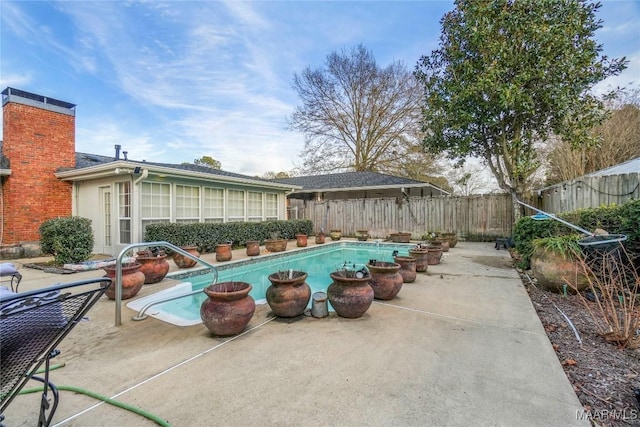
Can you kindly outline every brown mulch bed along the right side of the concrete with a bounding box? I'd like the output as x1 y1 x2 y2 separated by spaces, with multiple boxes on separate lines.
522 274 640 426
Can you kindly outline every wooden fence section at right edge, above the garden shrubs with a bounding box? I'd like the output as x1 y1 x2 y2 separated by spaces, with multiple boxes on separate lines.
538 173 640 213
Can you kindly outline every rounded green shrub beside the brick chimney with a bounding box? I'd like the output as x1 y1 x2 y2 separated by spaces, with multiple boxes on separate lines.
39 216 93 265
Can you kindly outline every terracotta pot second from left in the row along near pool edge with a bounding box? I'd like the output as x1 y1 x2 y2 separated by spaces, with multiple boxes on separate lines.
267 270 311 317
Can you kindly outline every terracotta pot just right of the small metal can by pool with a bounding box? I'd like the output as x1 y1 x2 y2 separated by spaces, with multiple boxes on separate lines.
327 272 374 318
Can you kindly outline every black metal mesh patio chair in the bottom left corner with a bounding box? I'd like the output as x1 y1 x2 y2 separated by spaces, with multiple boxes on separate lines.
0 277 111 426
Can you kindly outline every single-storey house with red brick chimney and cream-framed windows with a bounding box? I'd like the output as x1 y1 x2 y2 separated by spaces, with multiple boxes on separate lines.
0 88 298 258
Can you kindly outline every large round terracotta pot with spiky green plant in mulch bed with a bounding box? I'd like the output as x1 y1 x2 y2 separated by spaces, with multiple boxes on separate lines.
530 248 589 292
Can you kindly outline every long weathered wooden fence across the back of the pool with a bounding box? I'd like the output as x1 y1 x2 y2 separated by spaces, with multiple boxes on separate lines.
301 194 513 240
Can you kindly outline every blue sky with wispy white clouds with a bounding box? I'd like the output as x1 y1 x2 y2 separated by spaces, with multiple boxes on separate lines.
0 0 640 176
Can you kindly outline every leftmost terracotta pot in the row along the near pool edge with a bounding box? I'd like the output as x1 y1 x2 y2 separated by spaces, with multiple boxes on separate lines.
200 282 256 337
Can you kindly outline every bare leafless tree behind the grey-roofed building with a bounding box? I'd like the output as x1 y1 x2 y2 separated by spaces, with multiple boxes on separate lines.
289 45 430 174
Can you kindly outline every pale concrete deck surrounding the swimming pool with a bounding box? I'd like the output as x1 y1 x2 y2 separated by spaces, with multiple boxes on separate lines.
4 239 590 427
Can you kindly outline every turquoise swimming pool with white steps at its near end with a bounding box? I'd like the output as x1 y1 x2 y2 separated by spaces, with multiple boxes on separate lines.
127 242 414 326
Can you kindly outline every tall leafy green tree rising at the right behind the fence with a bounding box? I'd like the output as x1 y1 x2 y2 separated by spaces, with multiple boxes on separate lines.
415 0 625 218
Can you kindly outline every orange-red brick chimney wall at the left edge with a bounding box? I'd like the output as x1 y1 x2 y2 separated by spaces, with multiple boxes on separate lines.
0 102 75 244
